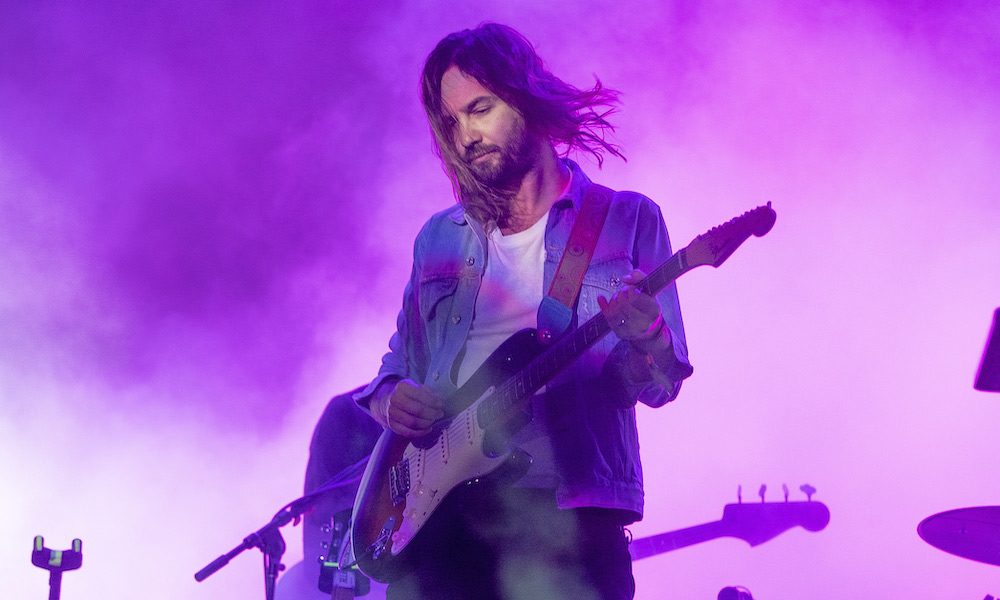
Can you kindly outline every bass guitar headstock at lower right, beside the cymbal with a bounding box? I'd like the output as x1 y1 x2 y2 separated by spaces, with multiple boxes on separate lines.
722 500 830 546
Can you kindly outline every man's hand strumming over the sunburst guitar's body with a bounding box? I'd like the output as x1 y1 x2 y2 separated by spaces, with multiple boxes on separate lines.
369 379 444 438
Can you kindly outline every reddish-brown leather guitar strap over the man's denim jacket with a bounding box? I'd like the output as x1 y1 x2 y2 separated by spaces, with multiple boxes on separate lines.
538 183 614 344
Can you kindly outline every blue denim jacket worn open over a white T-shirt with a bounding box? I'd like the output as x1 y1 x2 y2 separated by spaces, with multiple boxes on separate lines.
355 160 692 522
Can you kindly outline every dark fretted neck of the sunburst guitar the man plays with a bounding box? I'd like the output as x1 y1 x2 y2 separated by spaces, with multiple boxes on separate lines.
478 249 698 424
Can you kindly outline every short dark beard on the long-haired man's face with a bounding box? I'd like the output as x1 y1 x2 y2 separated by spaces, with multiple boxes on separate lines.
463 119 538 191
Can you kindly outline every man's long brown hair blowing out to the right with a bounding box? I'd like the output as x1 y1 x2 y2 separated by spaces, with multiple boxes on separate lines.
421 23 624 227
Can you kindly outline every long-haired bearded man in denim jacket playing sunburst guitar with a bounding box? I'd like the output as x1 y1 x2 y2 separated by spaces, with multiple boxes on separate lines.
356 24 691 600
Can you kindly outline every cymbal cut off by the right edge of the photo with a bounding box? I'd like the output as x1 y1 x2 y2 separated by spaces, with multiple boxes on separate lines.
917 506 1000 565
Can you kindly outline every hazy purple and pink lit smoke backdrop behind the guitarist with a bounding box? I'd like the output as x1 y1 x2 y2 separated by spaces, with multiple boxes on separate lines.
0 0 1000 600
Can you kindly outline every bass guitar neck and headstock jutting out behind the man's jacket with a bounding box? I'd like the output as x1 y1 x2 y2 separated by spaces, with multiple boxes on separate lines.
628 490 830 560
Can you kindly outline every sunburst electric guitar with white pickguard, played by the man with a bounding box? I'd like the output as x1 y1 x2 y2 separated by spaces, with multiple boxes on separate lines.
351 203 776 581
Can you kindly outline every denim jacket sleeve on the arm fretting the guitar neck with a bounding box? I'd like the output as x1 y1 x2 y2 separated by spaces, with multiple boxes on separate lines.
608 197 694 407
